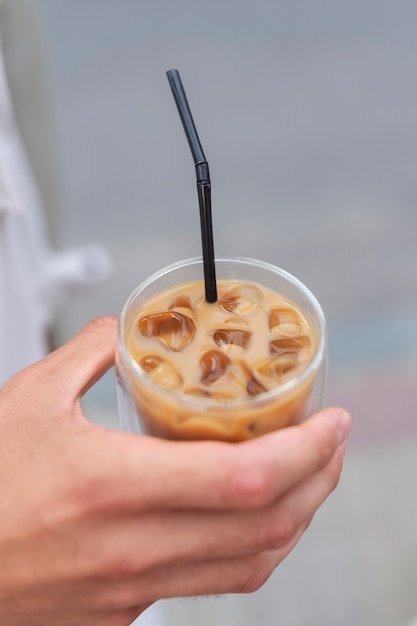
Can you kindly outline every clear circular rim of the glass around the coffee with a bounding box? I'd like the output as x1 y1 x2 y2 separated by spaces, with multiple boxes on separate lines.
117 257 327 408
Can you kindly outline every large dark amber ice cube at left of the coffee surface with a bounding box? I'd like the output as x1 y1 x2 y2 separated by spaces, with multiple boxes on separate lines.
138 311 195 352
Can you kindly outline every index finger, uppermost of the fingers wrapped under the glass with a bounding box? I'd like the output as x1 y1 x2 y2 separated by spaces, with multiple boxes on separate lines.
107 408 350 510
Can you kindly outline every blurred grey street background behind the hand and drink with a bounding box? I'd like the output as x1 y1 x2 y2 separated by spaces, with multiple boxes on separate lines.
0 0 417 626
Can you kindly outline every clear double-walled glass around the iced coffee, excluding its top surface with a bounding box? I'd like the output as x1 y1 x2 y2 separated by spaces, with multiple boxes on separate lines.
116 258 328 442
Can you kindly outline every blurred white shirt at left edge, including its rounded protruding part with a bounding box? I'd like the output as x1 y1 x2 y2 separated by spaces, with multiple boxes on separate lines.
0 34 110 386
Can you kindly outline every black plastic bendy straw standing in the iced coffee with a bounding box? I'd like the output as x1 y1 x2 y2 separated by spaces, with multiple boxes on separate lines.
167 70 217 302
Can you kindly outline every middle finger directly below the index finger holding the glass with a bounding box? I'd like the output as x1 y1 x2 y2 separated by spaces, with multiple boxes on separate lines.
79 436 342 578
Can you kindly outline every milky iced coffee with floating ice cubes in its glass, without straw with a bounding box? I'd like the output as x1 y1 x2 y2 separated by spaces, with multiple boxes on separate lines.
117 259 326 441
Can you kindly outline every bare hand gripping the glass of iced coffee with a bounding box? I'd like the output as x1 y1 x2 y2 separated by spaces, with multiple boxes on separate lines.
0 318 350 626
